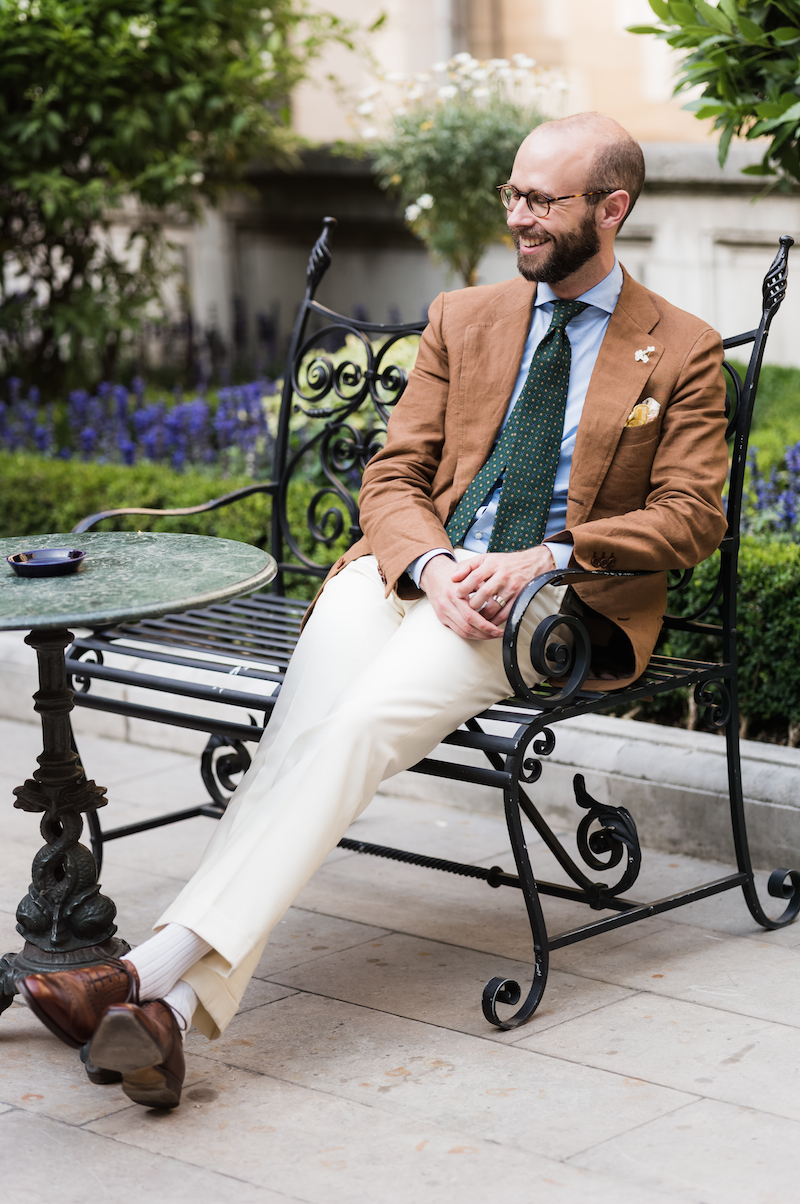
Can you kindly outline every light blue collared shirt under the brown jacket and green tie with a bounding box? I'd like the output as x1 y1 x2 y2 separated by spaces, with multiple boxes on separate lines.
407 259 622 586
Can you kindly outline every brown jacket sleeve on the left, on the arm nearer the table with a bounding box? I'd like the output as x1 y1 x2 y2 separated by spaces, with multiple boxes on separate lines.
359 294 452 589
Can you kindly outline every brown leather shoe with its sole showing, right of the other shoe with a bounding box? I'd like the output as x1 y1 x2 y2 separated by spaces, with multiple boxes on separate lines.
89 999 186 1108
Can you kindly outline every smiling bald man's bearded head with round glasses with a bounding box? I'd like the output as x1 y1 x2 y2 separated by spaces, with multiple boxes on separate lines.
507 113 645 296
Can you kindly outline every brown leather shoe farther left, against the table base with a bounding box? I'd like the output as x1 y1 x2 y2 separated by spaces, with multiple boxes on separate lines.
17 957 139 1050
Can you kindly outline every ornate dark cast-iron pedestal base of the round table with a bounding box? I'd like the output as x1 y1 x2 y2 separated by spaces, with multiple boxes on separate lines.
0 627 130 1011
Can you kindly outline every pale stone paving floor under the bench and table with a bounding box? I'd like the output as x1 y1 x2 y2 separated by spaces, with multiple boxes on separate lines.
0 721 800 1204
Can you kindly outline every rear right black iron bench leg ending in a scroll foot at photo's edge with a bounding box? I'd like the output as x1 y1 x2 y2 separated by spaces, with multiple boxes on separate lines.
708 680 800 928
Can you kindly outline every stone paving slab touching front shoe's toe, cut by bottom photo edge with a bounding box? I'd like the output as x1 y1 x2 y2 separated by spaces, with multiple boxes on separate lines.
88 1058 664 1204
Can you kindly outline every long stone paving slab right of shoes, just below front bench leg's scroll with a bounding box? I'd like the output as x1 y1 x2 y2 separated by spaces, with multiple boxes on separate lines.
184 993 696 1158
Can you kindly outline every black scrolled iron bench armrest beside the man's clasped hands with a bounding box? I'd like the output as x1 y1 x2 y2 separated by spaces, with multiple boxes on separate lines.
502 568 653 710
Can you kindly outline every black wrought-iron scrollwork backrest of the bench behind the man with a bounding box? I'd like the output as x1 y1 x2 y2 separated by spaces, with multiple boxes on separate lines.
271 218 794 659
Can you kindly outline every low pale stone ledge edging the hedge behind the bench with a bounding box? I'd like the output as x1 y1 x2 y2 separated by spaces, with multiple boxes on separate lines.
0 632 800 869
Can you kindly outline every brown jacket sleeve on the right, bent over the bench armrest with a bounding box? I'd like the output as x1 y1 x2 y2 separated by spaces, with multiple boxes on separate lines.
570 327 728 571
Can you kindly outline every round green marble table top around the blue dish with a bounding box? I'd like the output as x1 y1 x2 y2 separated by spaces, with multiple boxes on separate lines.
0 531 277 631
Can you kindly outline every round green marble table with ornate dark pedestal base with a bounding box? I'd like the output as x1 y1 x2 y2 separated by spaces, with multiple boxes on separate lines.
0 531 276 1011
